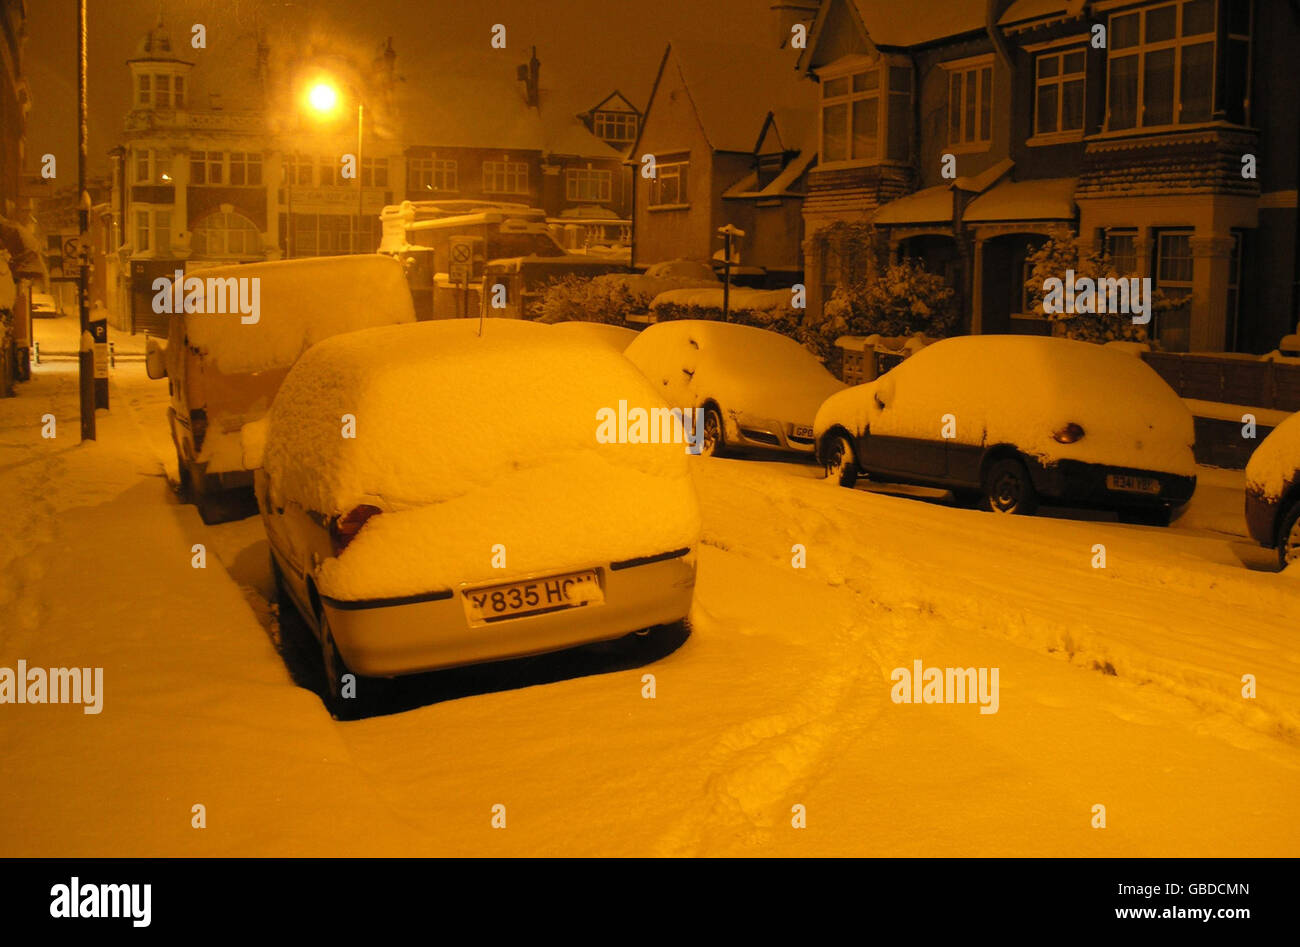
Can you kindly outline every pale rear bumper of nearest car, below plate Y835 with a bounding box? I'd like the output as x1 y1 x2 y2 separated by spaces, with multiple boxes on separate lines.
322 550 696 678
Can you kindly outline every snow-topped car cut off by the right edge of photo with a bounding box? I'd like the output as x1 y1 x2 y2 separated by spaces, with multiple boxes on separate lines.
1245 414 1300 568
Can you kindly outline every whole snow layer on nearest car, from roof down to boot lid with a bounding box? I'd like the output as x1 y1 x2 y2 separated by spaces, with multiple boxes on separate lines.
264 319 699 598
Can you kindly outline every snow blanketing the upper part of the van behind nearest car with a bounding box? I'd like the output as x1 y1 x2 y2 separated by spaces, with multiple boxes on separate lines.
173 254 415 375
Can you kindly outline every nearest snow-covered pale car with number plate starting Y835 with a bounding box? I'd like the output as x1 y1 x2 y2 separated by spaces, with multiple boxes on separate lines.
256 319 699 710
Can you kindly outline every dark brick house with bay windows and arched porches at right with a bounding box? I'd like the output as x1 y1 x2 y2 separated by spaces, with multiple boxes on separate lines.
800 0 1300 353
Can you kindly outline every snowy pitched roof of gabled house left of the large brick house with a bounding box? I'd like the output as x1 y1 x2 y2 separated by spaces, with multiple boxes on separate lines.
633 40 816 153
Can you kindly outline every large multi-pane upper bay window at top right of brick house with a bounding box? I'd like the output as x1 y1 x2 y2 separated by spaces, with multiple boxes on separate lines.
1106 0 1216 130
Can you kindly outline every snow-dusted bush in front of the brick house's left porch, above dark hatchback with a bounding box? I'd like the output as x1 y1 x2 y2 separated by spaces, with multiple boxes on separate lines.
826 259 958 338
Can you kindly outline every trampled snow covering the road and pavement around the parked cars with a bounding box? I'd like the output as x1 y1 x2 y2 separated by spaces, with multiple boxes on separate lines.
0 317 1300 856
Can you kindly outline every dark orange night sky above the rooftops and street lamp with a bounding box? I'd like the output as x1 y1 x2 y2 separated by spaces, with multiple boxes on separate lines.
23 0 774 173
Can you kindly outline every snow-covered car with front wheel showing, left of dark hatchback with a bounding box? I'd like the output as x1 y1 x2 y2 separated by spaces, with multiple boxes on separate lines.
624 319 844 454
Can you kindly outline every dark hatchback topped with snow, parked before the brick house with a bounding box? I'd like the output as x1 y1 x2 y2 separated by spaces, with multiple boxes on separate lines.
814 336 1196 526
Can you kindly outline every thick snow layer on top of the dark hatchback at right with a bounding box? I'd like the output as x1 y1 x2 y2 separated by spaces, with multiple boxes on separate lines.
814 336 1196 476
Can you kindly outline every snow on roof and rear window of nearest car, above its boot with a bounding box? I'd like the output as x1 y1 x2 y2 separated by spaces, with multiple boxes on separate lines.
264 319 685 514
